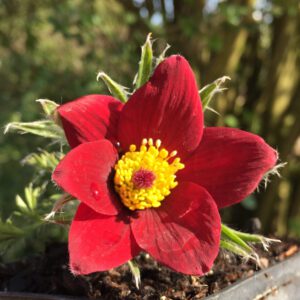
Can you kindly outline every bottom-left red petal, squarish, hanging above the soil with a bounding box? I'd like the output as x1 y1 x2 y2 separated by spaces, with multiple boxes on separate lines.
69 204 139 274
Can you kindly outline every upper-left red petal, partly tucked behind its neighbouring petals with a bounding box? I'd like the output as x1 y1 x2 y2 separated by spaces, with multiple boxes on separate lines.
58 95 123 148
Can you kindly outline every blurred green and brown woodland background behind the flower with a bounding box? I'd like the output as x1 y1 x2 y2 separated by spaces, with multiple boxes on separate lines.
0 0 300 236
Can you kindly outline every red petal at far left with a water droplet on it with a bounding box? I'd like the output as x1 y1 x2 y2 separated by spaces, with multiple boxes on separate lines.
52 140 119 215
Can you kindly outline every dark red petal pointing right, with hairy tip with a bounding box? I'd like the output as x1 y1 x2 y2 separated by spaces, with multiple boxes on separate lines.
178 127 277 208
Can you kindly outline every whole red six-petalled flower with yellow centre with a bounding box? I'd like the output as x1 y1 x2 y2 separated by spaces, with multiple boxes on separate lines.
53 55 277 275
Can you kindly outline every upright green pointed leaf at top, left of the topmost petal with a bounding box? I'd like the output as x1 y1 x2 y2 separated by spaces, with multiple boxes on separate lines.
135 33 153 89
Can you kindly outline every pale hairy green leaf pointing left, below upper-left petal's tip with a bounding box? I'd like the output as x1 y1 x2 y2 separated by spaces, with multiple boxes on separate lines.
4 120 65 141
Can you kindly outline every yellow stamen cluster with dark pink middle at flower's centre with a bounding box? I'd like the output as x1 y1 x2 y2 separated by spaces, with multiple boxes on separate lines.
114 138 184 210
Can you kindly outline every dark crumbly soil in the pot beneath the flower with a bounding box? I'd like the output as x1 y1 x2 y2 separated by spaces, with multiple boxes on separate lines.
0 241 299 300
